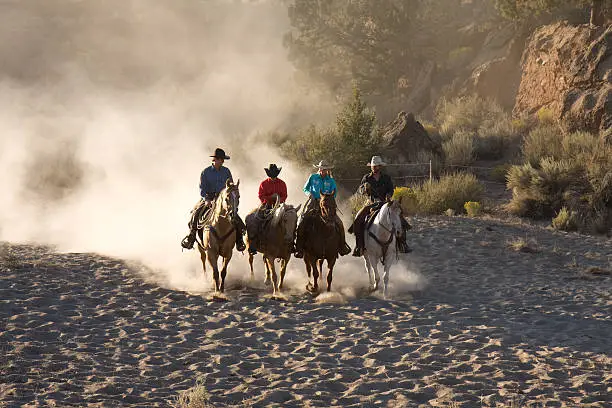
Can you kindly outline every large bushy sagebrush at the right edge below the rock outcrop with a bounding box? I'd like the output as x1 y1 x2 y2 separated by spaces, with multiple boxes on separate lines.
507 125 612 232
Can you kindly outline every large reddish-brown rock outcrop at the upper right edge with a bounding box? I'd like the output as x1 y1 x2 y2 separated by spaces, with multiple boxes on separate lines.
513 22 612 132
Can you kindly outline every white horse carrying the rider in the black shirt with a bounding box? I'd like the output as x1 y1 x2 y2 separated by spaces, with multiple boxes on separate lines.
363 199 402 298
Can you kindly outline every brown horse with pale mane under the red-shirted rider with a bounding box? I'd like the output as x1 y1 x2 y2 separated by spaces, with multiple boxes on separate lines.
246 203 301 295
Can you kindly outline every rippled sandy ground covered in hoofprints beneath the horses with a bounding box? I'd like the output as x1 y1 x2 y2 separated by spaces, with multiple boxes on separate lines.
0 217 612 407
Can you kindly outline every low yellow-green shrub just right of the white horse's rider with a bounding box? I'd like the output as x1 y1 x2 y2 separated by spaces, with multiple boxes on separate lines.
414 173 484 214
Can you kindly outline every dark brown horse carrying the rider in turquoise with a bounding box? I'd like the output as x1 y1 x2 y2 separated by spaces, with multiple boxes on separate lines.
302 193 343 293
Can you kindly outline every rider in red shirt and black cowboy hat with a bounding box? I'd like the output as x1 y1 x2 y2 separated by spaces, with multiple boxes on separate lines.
246 164 287 255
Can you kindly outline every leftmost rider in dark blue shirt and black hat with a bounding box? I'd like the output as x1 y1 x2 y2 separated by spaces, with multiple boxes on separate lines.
181 148 246 252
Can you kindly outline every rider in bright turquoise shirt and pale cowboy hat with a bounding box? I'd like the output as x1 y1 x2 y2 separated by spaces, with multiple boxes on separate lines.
295 160 351 258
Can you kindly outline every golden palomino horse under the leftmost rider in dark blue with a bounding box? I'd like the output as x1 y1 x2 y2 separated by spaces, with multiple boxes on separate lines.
198 180 240 293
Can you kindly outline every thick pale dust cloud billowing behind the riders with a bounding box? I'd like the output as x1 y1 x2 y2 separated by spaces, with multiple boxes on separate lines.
0 0 424 291
